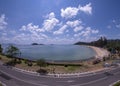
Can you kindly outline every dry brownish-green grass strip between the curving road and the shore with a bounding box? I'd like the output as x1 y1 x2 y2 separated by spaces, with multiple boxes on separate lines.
0 55 118 73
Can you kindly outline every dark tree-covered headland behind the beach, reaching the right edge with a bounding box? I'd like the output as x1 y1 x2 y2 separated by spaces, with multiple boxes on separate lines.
75 37 120 53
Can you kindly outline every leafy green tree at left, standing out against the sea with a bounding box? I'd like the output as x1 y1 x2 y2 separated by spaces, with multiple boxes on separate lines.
6 45 20 57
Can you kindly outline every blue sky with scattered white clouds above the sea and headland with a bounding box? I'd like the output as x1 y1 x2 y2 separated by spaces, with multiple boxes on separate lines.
0 0 120 44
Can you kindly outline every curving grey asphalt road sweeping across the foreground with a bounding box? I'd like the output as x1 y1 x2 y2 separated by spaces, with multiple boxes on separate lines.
0 64 120 86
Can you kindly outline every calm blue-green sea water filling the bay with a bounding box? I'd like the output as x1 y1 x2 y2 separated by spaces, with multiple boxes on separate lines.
2 44 96 61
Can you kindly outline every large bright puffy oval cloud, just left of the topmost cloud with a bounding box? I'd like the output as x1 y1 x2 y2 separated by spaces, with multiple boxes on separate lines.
61 7 79 18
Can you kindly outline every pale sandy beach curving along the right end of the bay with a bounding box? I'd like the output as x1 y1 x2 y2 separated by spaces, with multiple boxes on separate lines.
89 46 109 59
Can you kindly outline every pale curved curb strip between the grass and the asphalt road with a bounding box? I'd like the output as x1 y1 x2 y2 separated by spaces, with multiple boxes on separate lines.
13 67 110 77
